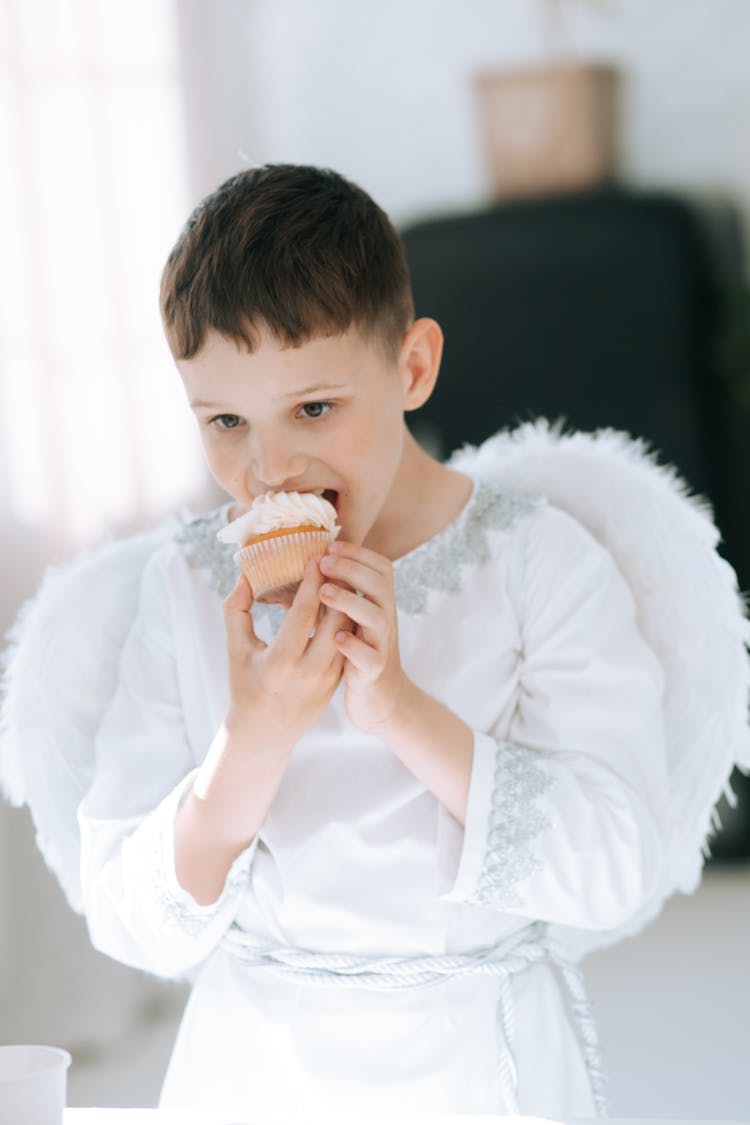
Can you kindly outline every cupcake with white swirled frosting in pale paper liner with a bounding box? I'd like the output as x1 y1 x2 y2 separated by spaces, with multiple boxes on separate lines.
217 492 341 602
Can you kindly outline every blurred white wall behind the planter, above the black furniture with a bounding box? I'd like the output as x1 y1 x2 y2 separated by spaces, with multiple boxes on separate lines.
182 0 750 247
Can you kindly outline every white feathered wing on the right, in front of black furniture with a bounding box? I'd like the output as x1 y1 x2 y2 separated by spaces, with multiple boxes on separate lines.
450 419 750 956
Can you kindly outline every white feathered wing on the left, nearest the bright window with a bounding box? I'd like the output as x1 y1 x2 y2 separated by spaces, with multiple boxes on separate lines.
0 521 178 914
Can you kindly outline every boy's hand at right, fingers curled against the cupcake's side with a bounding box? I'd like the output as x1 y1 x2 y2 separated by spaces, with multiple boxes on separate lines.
319 541 414 734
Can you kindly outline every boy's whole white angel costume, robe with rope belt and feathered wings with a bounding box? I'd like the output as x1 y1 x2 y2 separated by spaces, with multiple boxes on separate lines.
3 421 750 1117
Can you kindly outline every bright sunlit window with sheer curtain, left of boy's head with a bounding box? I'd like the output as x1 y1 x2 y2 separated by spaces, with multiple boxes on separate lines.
0 0 206 549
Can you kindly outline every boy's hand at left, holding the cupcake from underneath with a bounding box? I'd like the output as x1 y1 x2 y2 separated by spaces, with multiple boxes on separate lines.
224 559 347 752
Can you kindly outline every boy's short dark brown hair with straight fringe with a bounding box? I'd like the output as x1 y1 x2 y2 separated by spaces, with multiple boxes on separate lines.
160 164 414 359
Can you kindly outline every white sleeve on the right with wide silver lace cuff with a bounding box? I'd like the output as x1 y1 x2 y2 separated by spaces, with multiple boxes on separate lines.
443 507 667 929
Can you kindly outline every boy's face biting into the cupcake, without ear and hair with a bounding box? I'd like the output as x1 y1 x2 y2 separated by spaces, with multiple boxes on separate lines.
177 329 422 543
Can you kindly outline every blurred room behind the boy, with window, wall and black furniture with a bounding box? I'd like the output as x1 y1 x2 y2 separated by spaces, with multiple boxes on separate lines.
0 0 750 1119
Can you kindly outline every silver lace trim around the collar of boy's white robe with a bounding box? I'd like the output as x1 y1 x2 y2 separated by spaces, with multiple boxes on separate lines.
175 480 543 617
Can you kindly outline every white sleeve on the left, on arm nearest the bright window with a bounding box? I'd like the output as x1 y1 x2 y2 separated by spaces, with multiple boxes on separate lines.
79 549 255 977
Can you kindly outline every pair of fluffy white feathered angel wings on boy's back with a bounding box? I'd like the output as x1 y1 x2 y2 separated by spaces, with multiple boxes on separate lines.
0 420 750 955
